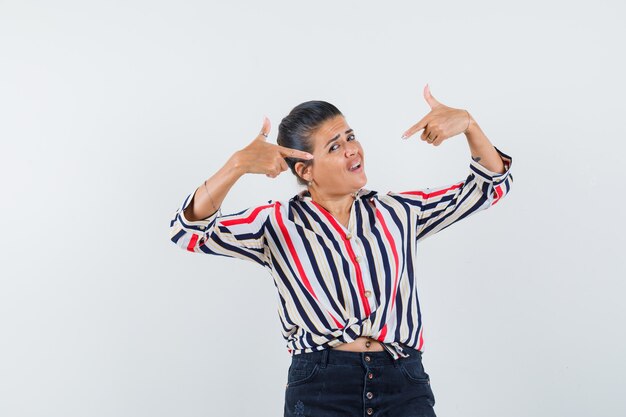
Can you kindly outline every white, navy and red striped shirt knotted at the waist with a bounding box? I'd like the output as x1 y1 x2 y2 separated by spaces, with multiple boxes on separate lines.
170 148 513 358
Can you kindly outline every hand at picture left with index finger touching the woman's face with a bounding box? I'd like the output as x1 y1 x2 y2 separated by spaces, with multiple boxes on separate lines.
235 117 313 178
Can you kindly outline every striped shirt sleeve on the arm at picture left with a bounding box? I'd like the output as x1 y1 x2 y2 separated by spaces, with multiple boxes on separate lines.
170 186 274 266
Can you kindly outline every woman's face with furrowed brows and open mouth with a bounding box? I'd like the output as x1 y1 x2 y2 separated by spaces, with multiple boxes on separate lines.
301 115 367 195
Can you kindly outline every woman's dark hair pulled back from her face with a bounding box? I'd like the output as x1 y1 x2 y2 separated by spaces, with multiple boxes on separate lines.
276 100 343 185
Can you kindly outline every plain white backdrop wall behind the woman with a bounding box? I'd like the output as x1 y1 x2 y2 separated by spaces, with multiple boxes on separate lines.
0 0 626 417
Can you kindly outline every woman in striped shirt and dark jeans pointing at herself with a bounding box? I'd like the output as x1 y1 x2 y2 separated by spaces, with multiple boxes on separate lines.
171 85 513 417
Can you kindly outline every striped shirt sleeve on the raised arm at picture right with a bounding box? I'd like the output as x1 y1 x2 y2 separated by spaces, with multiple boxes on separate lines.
388 148 513 241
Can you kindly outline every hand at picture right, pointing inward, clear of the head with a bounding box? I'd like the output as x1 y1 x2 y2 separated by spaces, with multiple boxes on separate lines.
402 84 472 146
